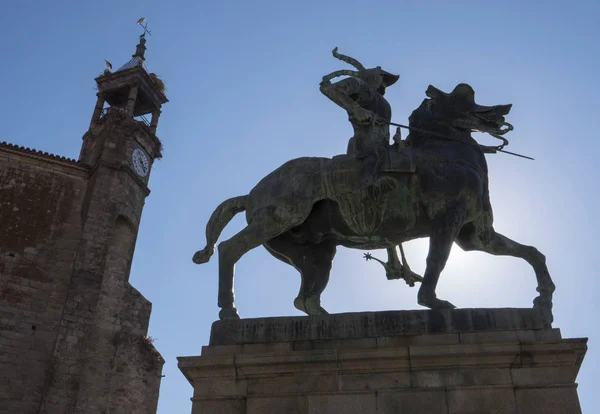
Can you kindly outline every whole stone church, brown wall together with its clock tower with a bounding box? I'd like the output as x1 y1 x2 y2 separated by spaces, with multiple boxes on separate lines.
0 33 168 414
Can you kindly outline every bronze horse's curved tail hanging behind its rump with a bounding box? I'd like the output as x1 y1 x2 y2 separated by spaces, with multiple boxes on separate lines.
192 195 248 264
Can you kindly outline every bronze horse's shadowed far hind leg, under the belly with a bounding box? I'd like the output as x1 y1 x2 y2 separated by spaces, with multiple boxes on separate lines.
266 236 336 315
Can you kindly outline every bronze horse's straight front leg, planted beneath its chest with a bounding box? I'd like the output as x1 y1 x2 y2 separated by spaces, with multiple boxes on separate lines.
417 210 464 309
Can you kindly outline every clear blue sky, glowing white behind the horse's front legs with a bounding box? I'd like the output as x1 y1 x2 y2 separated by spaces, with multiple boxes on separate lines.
0 0 600 414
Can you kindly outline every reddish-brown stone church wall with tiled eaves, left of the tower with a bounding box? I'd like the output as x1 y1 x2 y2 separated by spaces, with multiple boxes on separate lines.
0 148 87 414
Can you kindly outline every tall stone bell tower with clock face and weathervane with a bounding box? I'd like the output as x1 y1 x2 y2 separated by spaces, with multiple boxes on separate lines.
44 28 168 413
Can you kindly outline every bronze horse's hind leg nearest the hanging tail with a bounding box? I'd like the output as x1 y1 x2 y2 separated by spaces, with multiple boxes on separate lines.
218 220 285 319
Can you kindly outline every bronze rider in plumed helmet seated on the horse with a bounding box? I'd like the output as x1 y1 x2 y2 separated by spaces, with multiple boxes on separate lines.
320 48 400 186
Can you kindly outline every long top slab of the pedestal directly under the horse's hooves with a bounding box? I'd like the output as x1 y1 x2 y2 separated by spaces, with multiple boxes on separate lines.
210 309 550 346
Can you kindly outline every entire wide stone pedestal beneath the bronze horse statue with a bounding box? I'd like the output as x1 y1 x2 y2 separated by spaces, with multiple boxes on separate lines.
179 309 587 414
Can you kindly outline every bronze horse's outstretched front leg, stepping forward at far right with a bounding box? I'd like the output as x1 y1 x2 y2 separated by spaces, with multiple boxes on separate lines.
456 227 555 310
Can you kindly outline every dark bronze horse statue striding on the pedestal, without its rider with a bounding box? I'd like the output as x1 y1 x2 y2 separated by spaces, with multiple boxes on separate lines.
193 84 554 319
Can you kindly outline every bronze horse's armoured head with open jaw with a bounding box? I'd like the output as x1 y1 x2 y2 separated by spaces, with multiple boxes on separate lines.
409 83 513 146
